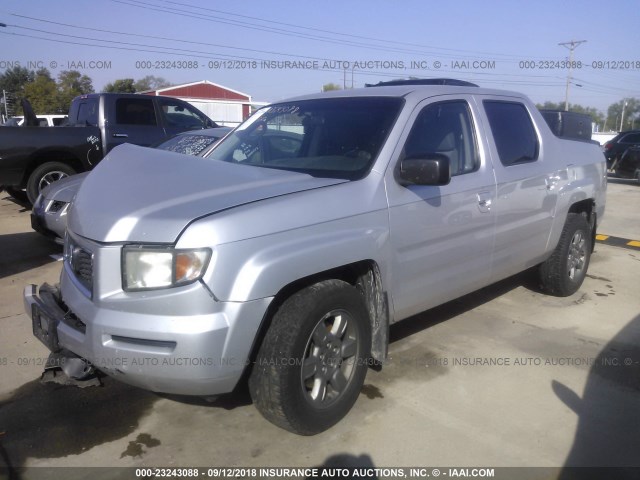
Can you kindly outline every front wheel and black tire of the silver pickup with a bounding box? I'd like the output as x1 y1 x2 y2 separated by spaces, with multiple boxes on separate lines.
249 280 371 435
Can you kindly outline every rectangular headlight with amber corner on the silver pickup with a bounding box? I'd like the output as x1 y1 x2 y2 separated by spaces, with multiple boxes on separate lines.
122 246 211 291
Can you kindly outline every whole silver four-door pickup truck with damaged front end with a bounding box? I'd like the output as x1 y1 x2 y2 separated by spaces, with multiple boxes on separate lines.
24 84 606 435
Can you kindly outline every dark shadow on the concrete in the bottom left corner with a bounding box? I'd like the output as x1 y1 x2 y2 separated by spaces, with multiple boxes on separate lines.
0 377 158 472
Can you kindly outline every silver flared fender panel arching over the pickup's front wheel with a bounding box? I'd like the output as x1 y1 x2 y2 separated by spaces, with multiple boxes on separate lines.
204 211 389 302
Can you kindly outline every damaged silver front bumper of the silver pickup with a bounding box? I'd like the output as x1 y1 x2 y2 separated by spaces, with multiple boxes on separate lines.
24 280 271 396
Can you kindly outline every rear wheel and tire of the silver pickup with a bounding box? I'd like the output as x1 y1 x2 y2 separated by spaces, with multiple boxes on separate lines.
539 213 593 297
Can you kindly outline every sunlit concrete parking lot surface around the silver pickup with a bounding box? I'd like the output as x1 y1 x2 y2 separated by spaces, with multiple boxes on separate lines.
0 179 640 476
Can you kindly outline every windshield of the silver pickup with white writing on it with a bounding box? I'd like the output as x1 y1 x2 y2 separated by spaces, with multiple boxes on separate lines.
209 97 402 180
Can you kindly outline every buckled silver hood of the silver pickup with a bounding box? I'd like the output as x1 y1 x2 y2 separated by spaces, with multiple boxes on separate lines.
68 144 347 243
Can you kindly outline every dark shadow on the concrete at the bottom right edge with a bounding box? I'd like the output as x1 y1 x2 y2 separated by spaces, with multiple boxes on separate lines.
551 315 640 474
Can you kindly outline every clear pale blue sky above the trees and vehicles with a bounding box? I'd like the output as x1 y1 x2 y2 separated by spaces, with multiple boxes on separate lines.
0 0 640 116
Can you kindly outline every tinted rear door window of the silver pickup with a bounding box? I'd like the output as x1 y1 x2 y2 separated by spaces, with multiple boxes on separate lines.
483 100 539 167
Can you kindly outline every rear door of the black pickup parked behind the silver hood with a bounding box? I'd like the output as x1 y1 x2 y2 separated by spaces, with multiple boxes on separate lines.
105 95 165 151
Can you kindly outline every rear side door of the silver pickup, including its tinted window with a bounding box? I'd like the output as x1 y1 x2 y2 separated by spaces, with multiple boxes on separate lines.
479 96 567 280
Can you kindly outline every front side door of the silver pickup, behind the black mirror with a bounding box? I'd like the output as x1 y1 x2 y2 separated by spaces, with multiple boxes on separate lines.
385 95 496 320
